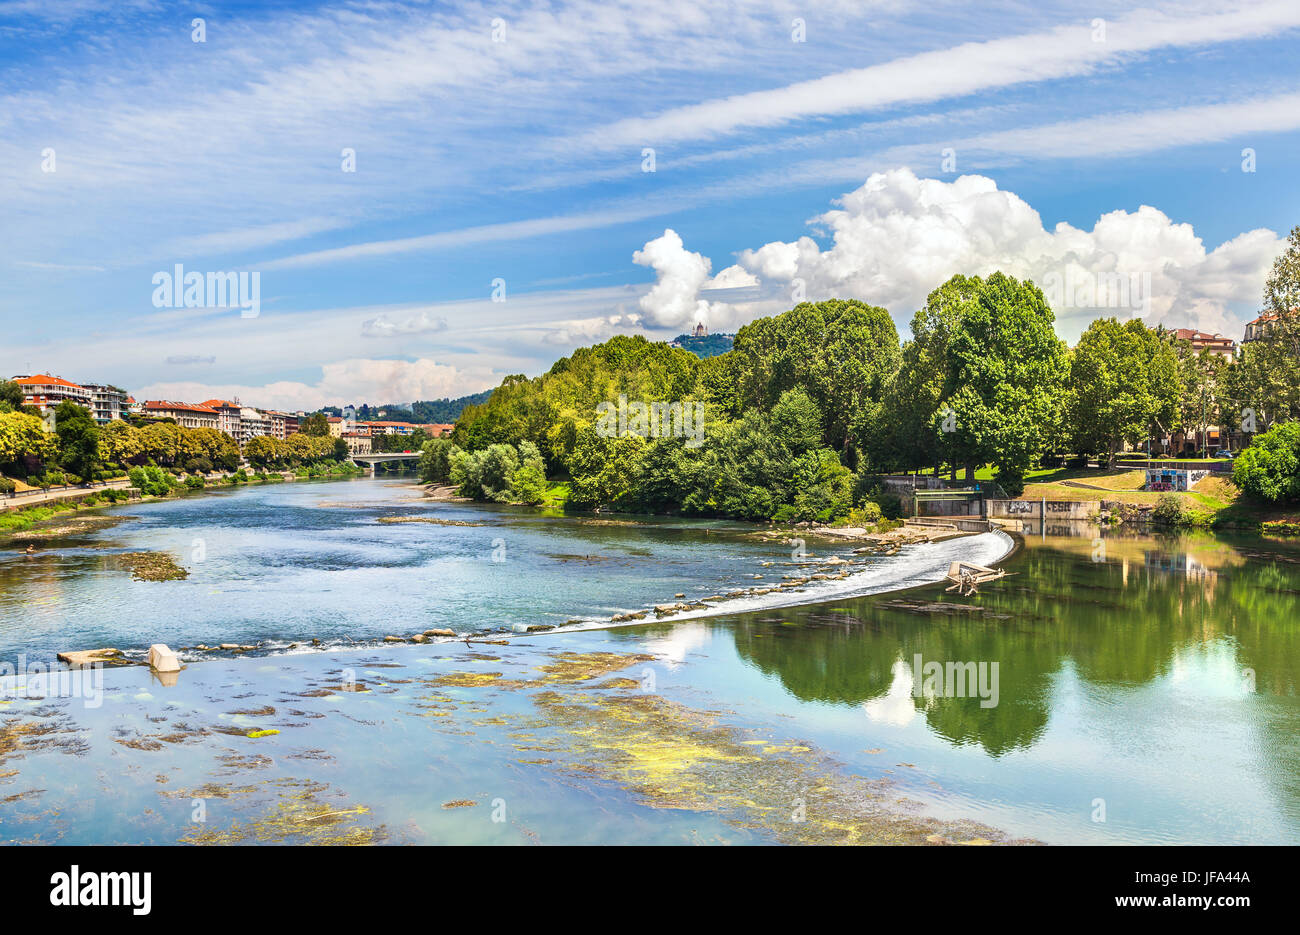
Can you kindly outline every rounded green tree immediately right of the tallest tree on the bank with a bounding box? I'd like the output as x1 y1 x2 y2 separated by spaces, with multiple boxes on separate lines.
1065 319 1179 467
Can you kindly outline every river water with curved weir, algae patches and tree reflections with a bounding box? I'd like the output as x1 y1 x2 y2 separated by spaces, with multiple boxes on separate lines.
0 480 1300 844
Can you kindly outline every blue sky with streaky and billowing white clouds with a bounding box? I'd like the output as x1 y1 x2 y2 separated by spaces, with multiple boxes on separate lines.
0 0 1300 410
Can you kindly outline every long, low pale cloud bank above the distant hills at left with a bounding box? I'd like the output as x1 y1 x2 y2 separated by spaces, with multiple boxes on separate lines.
135 358 498 411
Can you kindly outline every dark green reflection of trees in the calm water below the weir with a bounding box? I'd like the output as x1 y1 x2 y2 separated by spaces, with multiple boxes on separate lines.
735 541 1300 756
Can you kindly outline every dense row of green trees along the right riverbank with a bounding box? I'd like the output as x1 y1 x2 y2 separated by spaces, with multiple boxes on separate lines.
431 228 1300 520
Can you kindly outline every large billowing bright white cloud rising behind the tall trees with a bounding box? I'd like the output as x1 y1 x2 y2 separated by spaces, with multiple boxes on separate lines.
733 169 1283 338
